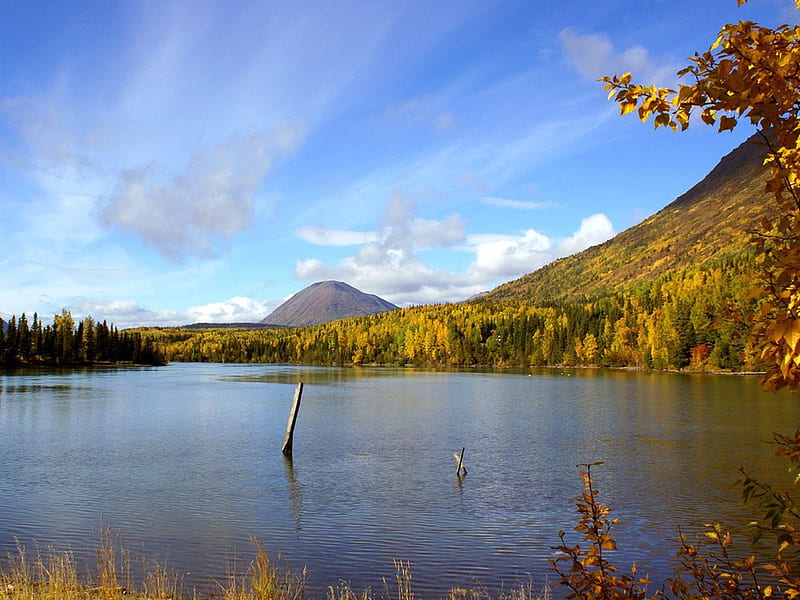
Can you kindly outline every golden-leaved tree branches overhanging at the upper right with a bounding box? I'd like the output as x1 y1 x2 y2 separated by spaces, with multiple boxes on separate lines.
602 0 800 390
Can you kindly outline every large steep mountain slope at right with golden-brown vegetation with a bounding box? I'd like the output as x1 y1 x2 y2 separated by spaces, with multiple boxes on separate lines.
478 136 774 305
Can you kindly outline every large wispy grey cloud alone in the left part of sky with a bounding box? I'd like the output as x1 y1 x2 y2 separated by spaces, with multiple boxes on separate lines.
101 127 302 259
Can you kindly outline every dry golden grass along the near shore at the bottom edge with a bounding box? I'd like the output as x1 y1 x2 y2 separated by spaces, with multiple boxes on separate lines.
0 529 550 600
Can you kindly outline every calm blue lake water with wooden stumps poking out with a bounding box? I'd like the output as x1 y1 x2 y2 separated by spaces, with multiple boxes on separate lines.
0 364 800 598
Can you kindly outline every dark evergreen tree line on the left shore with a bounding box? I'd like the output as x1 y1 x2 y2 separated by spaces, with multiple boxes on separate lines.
0 310 164 366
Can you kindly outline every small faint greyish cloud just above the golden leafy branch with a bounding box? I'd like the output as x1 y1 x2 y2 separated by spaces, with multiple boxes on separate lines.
558 27 680 85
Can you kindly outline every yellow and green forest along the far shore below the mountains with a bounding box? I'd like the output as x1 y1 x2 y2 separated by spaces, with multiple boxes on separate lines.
143 256 759 371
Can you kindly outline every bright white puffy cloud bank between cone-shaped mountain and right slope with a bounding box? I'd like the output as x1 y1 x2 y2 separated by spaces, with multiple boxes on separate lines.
295 194 614 305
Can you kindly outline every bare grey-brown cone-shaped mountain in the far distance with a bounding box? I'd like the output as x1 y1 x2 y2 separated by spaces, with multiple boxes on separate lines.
261 281 397 327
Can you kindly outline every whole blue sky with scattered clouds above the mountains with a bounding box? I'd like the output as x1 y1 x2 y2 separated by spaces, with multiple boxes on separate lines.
0 0 800 328
